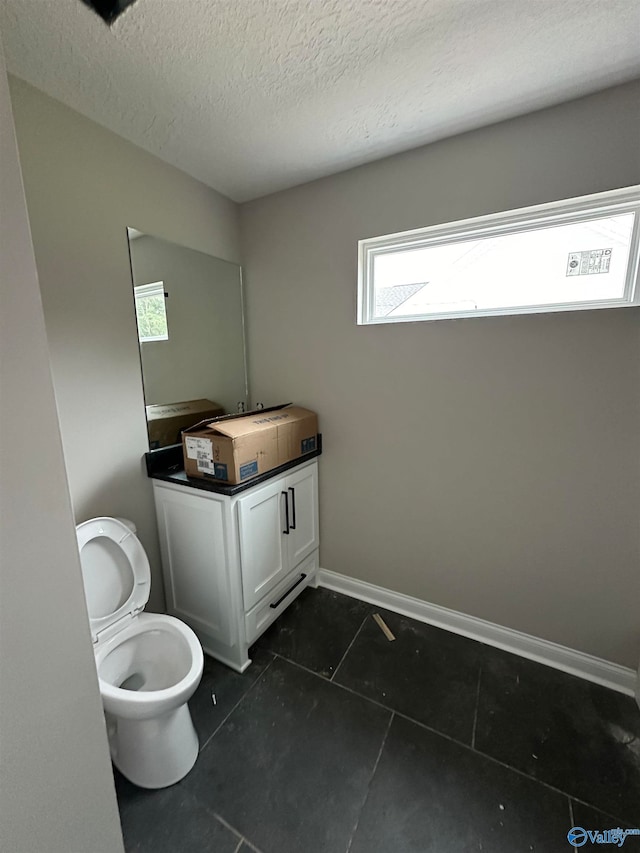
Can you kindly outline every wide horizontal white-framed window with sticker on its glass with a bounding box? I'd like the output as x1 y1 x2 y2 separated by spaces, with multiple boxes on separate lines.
358 187 640 324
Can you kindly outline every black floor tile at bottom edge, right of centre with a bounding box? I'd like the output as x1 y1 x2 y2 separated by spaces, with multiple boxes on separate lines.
350 717 570 853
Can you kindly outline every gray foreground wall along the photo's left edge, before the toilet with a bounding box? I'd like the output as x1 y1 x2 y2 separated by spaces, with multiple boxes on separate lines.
0 48 123 853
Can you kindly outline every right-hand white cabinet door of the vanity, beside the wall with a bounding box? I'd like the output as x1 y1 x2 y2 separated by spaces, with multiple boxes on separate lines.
284 465 320 569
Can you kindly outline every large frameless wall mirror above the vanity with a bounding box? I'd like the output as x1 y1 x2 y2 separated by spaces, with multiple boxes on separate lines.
127 228 248 449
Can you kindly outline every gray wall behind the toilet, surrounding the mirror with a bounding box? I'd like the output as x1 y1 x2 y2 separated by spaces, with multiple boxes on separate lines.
10 78 239 610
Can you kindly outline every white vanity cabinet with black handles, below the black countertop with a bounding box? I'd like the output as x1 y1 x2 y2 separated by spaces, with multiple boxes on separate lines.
153 459 319 672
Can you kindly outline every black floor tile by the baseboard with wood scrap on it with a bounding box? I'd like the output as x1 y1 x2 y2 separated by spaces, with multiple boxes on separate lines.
334 611 482 743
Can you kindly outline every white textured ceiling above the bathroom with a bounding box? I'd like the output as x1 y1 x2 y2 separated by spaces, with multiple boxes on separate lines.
0 0 640 201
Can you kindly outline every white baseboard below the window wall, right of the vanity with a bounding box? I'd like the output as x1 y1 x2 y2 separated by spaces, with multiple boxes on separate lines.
318 569 636 696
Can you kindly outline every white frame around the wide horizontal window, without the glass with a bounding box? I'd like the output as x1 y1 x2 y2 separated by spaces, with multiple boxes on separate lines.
357 185 640 325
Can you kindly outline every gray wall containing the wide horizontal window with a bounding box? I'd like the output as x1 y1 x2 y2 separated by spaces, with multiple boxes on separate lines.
241 78 640 666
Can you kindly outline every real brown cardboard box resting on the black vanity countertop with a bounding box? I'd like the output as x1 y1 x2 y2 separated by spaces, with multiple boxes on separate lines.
182 406 318 485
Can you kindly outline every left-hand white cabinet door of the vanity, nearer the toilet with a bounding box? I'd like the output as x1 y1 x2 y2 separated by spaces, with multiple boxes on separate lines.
238 478 289 611
